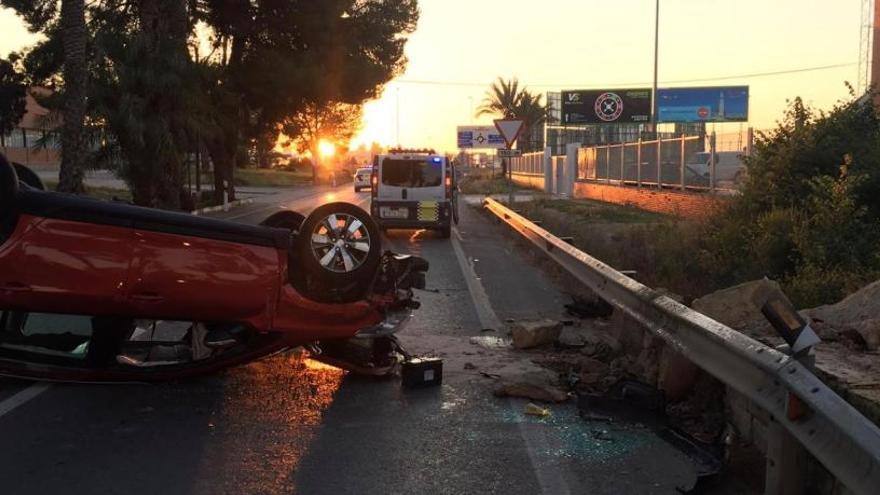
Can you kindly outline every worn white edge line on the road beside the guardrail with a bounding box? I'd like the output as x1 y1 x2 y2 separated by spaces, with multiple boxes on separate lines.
452 227 571 495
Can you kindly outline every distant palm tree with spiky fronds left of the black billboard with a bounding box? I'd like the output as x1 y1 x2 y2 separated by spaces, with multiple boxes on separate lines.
476 77 548 151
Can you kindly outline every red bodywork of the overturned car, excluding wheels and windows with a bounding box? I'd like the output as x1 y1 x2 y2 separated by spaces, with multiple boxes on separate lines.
0 157 426 379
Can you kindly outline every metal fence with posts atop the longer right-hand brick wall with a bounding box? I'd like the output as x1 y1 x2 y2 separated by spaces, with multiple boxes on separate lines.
577 136 743 190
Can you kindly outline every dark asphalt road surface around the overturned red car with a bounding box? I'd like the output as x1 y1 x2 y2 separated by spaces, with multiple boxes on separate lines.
0 186 693 495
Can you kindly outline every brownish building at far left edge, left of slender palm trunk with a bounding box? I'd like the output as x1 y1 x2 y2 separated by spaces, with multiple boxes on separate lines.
0 88 61 169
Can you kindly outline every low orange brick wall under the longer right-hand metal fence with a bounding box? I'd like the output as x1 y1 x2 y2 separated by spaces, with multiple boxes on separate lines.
574 182 725 218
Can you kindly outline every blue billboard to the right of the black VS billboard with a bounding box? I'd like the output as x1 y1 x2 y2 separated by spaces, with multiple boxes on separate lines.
657 86 749 123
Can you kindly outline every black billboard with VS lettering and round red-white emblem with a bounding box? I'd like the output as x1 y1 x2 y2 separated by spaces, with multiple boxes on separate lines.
562 89 652 125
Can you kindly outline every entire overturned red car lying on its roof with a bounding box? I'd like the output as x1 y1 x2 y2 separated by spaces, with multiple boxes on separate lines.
0 155 428 381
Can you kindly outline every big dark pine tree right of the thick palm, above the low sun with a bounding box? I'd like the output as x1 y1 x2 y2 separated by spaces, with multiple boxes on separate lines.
200 0 418 202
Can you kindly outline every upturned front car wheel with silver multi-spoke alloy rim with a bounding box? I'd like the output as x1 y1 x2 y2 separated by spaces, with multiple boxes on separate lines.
296 203 382 303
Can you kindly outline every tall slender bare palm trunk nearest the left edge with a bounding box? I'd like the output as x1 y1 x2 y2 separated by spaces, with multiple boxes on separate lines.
58 0 88 193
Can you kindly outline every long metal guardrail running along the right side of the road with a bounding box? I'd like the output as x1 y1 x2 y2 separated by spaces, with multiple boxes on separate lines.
483 198 880 495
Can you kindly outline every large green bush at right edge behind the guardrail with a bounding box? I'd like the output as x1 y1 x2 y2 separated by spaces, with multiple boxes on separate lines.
661 93 880 307
